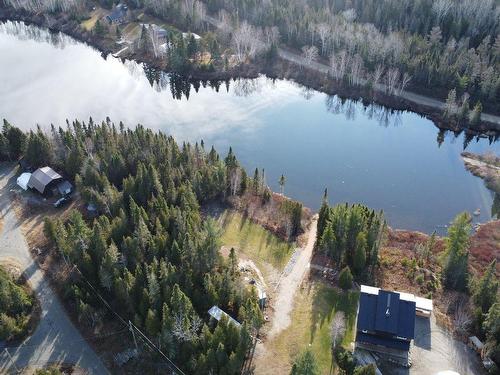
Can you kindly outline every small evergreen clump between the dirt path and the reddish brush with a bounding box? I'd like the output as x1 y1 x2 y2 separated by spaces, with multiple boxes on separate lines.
316 192 386 287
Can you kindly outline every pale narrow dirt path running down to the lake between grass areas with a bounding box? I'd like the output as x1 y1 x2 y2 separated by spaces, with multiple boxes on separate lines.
268 216 318 339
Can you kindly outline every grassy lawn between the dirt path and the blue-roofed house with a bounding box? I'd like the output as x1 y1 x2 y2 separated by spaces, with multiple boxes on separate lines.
256 281 359 374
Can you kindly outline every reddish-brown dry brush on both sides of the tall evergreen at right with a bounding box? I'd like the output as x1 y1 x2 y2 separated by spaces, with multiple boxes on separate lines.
377 225 500 336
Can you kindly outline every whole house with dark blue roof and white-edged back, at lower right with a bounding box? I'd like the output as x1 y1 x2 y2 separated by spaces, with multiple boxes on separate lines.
356 285 416 366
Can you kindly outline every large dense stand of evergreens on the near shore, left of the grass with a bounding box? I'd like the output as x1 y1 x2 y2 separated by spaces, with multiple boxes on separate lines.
2 119 276 374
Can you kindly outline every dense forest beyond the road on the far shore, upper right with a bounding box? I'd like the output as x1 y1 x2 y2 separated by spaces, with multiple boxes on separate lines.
198 0 500 111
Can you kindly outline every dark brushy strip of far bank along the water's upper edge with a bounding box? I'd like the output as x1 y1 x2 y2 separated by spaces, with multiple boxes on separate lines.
0 7 500 138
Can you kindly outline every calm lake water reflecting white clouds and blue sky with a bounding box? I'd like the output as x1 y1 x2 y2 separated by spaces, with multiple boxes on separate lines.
0 22 500 232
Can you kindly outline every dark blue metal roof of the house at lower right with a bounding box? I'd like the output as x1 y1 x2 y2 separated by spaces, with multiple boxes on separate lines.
357 290 415 339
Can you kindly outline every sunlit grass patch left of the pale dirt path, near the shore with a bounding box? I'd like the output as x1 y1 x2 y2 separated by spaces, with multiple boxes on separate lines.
219 210 295 271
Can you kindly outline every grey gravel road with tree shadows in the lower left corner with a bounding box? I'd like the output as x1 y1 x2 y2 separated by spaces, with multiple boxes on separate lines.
0 164 108 375
